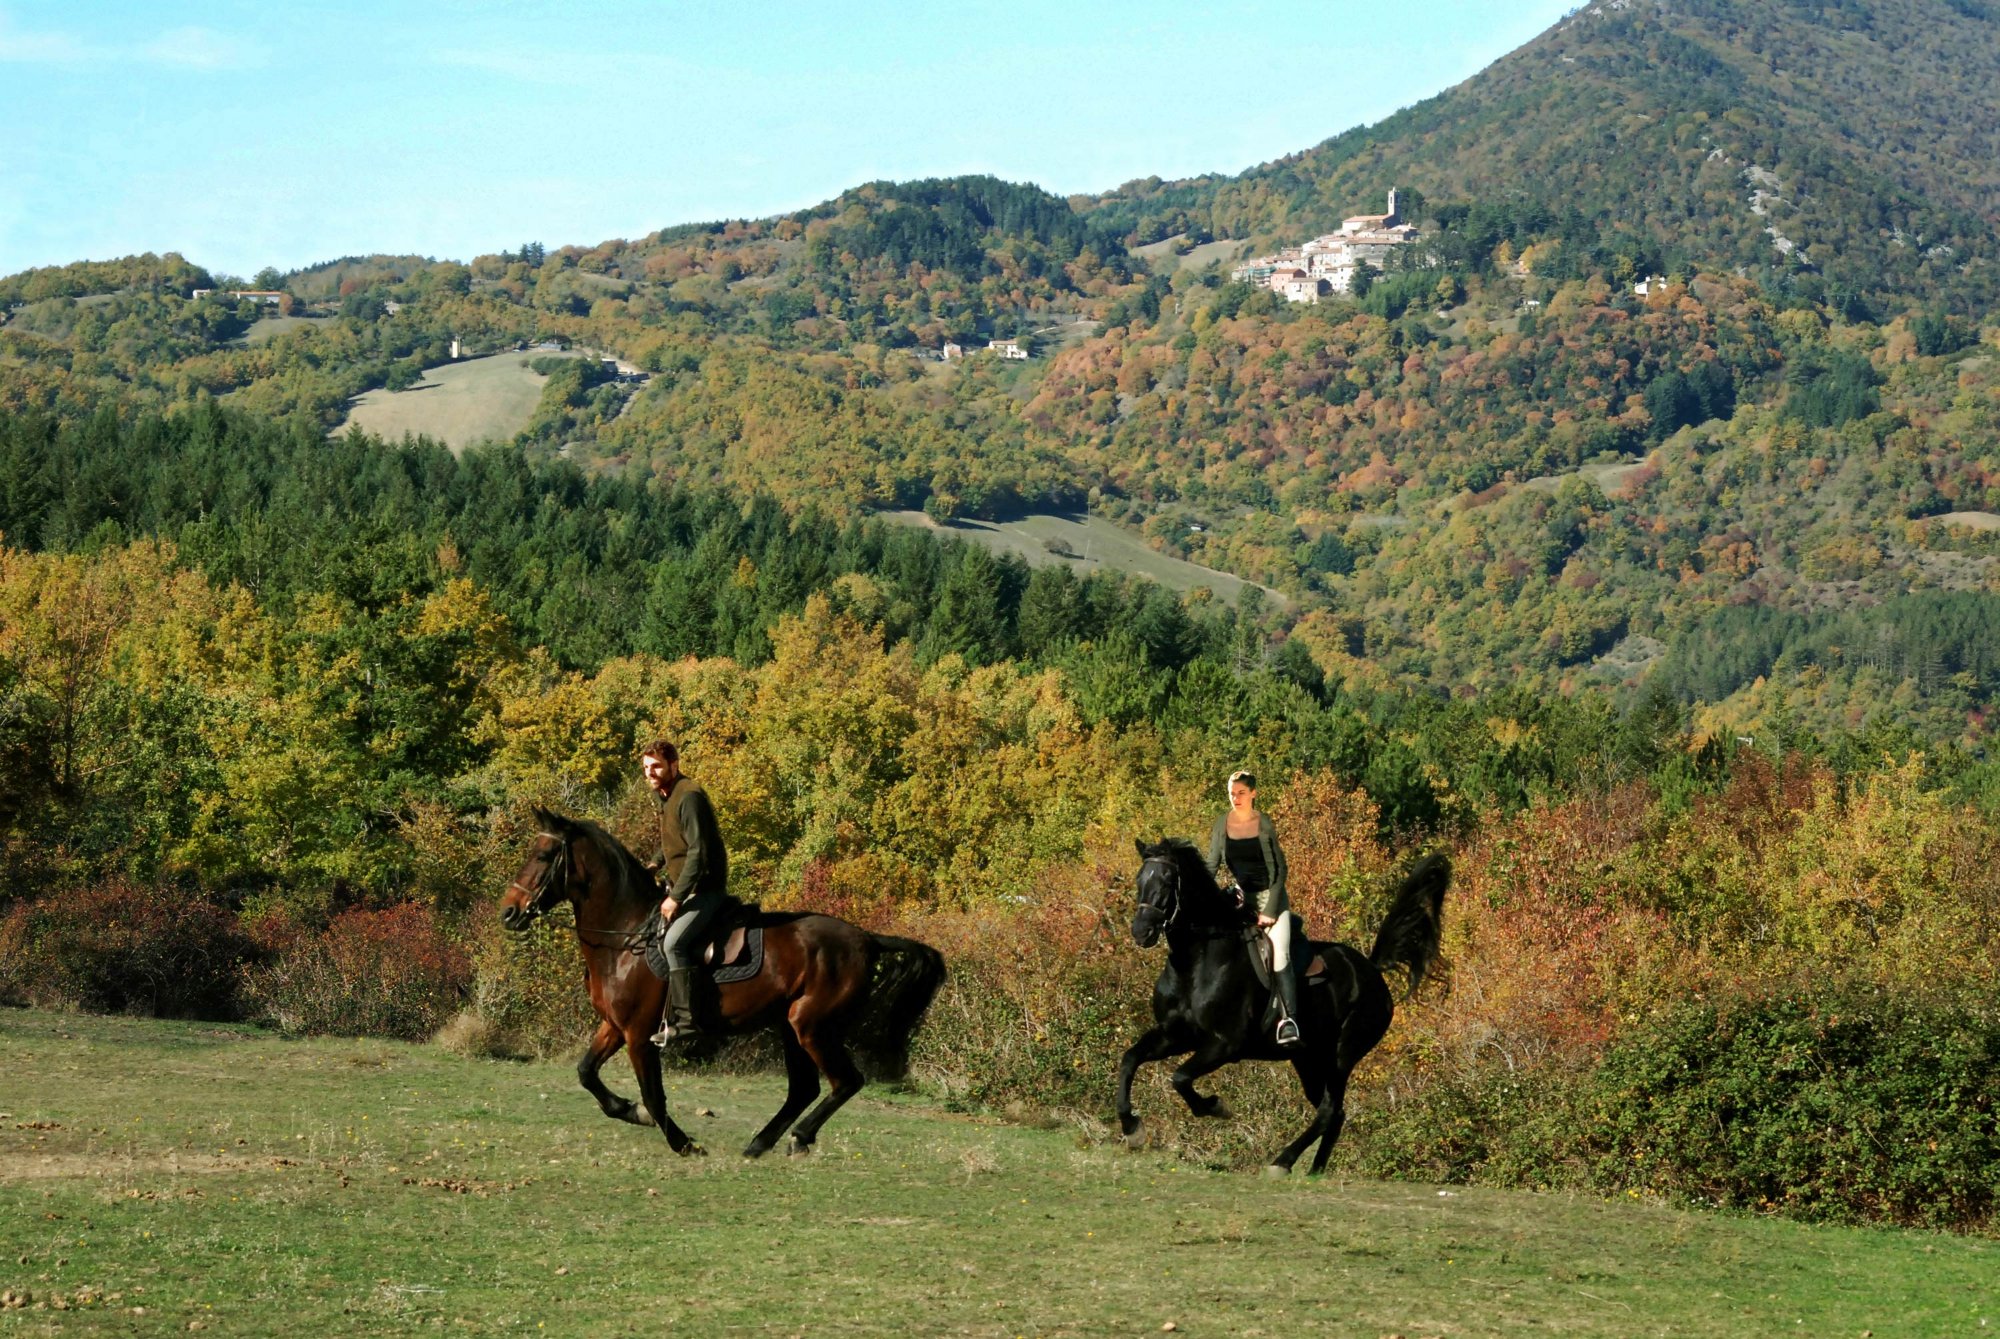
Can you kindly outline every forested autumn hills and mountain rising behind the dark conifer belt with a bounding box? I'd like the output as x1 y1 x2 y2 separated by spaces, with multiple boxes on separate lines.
0 0 2000 749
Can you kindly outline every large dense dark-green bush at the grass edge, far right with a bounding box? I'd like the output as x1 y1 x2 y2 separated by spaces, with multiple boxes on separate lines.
1586 991 2000 1229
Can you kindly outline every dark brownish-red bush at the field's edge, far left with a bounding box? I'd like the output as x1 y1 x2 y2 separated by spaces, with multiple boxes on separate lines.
0 881 252 1019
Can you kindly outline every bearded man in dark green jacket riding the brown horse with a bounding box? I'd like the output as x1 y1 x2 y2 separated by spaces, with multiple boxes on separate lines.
640 739 730 1047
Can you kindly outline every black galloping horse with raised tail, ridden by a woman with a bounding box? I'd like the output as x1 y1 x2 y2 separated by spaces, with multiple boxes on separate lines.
1118 841 1452 1175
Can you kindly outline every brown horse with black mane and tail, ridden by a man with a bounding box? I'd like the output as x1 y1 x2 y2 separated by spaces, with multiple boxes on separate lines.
500 807 944 1157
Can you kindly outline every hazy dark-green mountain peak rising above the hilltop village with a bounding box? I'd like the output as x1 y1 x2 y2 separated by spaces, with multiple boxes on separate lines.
1088 0 2000 310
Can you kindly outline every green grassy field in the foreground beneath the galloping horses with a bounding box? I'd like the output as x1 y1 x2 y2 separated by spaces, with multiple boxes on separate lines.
0 1011 2000 1339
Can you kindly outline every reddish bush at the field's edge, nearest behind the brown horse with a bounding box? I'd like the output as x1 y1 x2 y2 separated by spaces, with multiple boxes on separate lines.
244 901 472 1041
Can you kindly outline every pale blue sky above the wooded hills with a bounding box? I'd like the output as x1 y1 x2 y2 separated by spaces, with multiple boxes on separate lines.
0 0 1574 274
